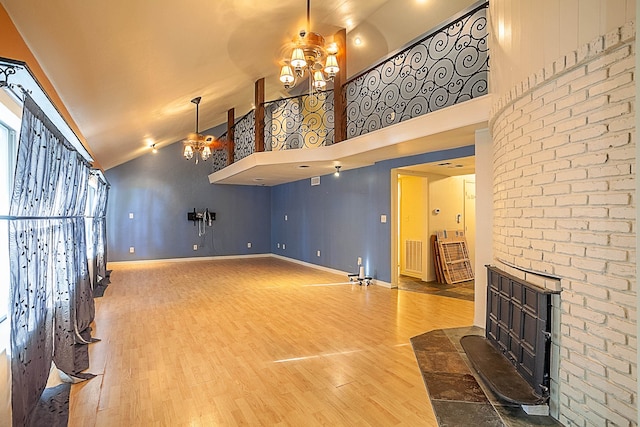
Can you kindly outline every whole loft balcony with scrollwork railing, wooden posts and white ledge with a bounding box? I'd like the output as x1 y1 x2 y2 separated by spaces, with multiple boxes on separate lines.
209 1 491 185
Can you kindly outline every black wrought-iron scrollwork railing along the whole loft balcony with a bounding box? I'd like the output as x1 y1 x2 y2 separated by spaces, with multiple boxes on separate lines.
214 1 489 172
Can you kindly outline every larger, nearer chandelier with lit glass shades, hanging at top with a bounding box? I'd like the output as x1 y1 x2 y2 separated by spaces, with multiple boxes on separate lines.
280 0 340 90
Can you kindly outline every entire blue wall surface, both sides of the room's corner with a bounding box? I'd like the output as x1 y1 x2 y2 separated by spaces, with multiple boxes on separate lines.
106 137 474 282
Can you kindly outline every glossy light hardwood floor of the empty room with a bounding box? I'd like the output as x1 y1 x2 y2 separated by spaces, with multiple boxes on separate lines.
69 257 473 427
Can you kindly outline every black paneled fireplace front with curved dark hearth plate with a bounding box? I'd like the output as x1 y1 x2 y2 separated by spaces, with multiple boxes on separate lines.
462 266 559 412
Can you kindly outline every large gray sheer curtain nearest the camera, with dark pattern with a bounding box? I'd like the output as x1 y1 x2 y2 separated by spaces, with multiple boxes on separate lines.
9 95 94 426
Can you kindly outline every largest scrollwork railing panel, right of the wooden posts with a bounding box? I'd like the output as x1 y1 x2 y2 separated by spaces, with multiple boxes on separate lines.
344 3 489 138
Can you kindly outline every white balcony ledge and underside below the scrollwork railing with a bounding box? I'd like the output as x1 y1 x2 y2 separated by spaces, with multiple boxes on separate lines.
209 94 491 186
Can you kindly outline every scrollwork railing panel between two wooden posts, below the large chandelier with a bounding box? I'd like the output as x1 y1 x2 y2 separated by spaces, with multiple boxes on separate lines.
264 91 334 151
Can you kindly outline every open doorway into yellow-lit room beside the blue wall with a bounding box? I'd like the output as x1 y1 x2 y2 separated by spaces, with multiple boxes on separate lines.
391 157 475 301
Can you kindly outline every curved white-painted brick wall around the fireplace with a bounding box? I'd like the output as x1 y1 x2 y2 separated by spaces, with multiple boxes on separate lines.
489 23 637 426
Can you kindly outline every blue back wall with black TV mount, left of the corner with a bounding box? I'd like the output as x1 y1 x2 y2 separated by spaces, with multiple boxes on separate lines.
105 130 271 261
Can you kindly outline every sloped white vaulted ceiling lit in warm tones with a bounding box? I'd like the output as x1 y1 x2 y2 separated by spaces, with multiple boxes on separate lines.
0 0 473 169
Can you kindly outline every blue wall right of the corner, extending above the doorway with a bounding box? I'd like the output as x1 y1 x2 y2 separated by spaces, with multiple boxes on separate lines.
271 146 474 282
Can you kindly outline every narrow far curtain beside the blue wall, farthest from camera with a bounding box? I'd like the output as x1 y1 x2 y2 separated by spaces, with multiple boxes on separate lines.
90 171 110 297
